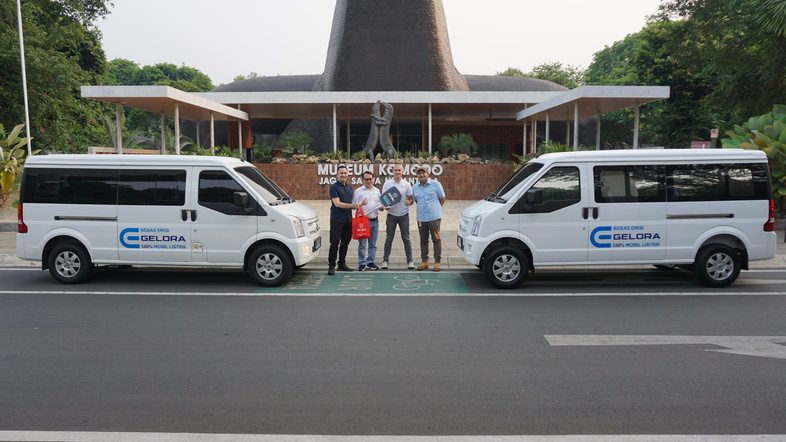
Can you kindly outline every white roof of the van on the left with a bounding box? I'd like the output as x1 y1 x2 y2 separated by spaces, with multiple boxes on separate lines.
25 154 245 167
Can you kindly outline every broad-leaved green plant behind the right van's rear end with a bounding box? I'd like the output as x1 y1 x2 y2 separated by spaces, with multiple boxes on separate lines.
721 104 786 210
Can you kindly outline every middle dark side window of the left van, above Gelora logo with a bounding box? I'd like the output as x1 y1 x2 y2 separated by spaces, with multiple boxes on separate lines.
118 170 186 206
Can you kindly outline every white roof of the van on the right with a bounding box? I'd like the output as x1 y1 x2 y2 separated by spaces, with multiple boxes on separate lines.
532 149 767 163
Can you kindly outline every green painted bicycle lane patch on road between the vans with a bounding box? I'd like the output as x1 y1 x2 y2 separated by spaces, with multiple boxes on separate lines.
256 272 470 295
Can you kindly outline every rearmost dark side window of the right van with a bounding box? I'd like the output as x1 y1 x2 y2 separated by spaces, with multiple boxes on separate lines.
666 163 770 201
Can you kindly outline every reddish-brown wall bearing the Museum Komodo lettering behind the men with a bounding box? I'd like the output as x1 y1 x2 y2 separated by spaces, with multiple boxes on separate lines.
256 163 514 200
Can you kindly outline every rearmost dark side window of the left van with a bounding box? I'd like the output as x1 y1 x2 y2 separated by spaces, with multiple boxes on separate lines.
22 168 118 205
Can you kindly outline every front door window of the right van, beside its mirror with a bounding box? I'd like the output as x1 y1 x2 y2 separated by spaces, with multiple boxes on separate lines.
510 167 581 213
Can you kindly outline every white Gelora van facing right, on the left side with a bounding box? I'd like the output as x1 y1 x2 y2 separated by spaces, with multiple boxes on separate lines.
16 155 321 286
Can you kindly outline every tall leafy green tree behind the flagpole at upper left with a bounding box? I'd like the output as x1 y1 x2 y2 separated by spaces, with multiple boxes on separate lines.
0 0 108 151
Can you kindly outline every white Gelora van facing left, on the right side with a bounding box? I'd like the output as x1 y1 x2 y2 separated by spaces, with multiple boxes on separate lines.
457 149 776 288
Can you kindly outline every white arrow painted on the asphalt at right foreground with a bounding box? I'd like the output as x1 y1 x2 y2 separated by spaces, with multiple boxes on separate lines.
544 335 786 359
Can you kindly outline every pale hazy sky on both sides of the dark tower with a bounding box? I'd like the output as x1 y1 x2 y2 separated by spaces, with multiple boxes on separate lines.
96 0 661 86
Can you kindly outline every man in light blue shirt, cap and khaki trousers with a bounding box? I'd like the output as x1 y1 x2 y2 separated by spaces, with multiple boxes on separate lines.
412 166 445 272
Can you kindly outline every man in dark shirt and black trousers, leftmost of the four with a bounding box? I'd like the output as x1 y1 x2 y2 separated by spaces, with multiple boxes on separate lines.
328 165 368 275
